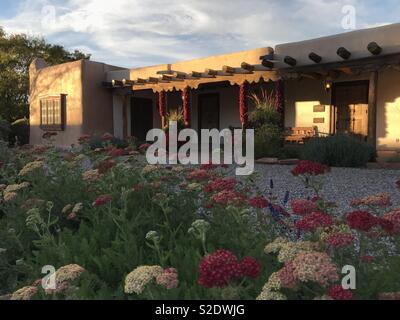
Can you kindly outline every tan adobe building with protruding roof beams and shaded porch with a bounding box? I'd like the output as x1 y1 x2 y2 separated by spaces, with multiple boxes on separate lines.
30 24 400 159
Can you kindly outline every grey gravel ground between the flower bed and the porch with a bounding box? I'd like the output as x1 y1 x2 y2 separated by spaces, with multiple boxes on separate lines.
256 165 400 215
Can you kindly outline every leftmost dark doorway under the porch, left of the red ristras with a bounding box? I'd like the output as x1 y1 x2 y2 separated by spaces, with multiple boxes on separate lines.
131 98 153 142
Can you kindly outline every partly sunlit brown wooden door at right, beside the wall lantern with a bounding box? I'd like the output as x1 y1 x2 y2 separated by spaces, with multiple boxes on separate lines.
332 81 369 140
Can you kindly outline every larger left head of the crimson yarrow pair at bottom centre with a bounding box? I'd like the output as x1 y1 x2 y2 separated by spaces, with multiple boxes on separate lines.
199 250 241 288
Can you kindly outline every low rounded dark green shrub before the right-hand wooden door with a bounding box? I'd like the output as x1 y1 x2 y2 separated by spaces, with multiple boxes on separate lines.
302 134 375 167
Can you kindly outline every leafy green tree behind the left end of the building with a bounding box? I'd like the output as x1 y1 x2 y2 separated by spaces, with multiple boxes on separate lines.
0 27 90 122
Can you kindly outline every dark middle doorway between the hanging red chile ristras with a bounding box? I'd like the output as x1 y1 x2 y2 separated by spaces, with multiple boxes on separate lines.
199 93 220 131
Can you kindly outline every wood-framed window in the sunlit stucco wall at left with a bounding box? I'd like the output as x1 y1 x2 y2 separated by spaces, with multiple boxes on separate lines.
40 95 66 131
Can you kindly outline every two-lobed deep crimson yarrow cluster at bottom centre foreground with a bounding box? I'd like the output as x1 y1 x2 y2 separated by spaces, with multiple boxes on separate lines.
199 250 261 288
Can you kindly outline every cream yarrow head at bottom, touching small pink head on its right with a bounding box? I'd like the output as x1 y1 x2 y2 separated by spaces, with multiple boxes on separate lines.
124 266 164 294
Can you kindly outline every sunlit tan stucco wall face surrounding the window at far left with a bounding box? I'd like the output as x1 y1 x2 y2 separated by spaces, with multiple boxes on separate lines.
30 61 83 146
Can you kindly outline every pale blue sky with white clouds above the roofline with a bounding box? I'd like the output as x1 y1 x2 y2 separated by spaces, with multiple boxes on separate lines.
0 0 400 68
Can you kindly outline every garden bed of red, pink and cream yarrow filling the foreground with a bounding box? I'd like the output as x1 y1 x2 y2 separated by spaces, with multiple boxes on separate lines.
0 135 400 300
